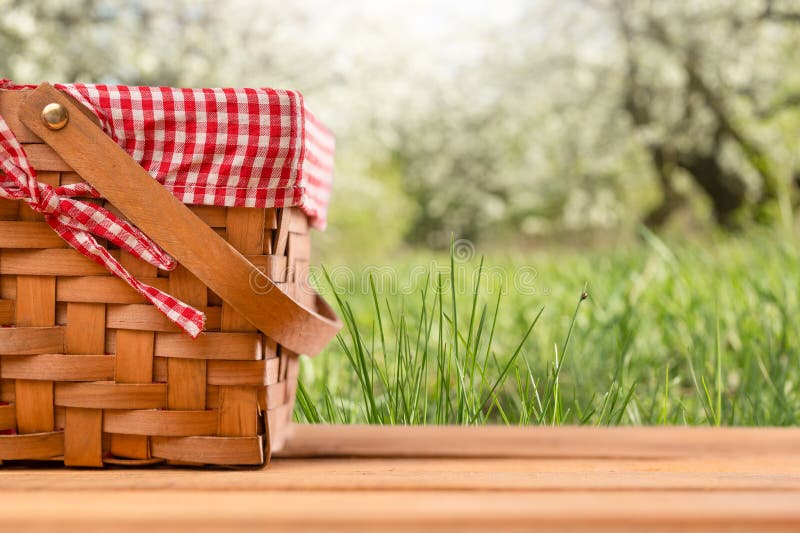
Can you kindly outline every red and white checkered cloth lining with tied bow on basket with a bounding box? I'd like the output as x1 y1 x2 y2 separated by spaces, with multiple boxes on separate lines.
0 80 334 337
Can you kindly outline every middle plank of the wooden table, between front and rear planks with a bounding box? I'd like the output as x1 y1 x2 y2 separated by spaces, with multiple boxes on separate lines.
0 456 800 492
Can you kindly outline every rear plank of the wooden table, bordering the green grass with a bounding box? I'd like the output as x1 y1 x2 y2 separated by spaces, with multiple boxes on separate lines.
281 425 800 459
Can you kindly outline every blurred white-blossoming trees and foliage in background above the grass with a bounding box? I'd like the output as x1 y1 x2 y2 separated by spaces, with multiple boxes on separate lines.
0 0 800 254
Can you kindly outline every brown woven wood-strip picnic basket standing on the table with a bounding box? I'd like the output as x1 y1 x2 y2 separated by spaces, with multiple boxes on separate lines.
0 86 336 466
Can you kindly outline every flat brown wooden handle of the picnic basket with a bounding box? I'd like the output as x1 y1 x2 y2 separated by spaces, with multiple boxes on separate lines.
19 83 342 355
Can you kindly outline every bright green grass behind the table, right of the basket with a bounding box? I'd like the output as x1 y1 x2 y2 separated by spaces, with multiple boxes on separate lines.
295 232 800 426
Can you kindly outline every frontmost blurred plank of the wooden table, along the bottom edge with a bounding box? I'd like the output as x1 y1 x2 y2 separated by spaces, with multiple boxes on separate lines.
3 489 800 532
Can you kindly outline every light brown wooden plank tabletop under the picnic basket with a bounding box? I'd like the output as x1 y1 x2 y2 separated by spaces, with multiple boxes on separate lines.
0 426 800 533
